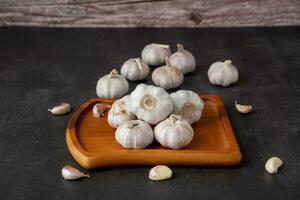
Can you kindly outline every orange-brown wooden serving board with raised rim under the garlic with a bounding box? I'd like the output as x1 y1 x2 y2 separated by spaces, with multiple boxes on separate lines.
66 96 242 169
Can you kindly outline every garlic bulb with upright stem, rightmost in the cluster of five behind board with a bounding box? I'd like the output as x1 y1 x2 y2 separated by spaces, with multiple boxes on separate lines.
170 44 196 74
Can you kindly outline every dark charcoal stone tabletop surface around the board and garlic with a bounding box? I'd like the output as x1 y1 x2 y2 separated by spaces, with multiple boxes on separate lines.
0 27 300 200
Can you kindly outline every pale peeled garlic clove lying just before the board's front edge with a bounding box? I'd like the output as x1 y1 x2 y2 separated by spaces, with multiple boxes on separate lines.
149 165 173 181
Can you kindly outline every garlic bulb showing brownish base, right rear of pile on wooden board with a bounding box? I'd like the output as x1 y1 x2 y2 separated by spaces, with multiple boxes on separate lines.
170 90 204 124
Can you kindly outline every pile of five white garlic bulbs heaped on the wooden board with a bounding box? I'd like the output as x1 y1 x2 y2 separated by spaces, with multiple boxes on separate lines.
107 84 204 149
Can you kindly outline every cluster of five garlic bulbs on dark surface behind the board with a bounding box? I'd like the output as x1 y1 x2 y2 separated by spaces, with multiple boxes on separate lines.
96 43 196 99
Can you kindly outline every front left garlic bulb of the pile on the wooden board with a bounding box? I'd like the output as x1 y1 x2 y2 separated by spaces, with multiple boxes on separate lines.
115 120 154 149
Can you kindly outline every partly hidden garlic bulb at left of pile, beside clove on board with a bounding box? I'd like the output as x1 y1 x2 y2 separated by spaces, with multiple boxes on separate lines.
107 95 136 128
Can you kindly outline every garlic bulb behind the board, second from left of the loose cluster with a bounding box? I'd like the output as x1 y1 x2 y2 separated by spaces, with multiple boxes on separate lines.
121 58 150 81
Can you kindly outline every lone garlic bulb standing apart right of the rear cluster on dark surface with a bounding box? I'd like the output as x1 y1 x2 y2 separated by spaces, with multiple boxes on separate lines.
207 60 239 87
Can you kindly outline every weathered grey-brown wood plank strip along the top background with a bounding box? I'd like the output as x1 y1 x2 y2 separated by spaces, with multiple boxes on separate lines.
0 0 300 27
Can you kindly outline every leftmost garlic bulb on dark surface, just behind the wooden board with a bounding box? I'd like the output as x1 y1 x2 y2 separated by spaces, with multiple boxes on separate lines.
96 69 129 99
